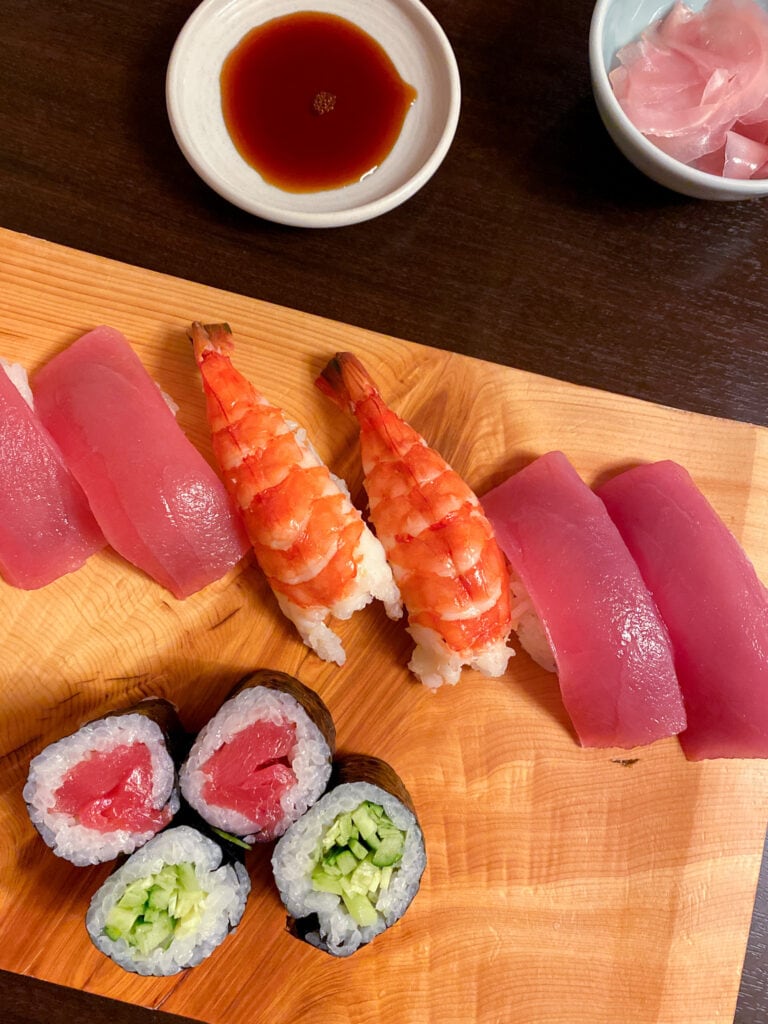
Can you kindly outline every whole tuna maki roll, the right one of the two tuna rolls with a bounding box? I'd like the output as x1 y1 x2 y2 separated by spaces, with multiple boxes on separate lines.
180 670 336 843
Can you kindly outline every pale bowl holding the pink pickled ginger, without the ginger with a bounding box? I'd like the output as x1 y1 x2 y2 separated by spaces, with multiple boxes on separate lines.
590 0 768 200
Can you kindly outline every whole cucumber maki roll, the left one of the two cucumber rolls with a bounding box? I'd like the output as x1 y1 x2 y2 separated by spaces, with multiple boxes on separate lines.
85 825 251 976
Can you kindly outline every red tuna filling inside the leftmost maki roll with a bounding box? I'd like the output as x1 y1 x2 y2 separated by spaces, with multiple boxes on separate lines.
50 743 172 833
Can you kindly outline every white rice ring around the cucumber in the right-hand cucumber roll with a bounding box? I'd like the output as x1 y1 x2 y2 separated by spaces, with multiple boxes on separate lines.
272 782 427 956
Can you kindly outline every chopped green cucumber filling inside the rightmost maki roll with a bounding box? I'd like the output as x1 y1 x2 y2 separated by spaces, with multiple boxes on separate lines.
312 800 406 927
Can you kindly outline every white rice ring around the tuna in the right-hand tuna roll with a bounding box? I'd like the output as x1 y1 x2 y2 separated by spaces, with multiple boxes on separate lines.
179 686 332 842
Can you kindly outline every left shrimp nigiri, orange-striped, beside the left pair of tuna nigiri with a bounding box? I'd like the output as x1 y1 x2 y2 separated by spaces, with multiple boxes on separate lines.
189 324 402 665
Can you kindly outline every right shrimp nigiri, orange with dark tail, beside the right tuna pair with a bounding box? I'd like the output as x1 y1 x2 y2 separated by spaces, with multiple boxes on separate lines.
316 352 513 689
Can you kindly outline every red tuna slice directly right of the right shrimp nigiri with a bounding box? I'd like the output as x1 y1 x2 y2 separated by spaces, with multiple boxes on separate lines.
482 452 685 748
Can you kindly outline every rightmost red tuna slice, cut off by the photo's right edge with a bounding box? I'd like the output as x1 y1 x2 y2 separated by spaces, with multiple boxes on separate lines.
598 462 768 761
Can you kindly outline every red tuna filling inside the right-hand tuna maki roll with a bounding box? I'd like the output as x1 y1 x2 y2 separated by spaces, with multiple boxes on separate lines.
201 720 296 838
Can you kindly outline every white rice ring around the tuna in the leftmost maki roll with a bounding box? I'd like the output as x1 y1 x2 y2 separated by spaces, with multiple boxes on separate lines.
24 713 179 867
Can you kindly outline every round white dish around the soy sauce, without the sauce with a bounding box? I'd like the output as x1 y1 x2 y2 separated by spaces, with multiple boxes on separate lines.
166 0 461 227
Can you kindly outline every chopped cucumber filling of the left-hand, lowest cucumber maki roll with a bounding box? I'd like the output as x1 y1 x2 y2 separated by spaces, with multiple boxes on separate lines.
104 863 208 956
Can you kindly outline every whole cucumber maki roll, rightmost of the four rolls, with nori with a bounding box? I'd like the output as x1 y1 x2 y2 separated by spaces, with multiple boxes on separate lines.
272 755 427 956
